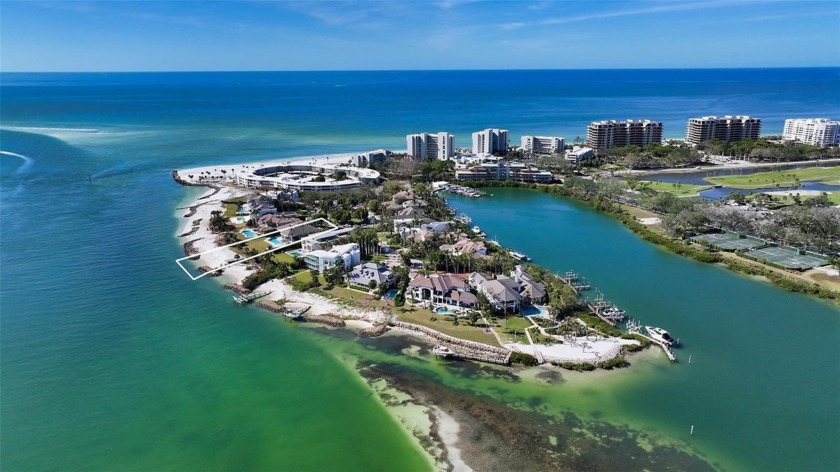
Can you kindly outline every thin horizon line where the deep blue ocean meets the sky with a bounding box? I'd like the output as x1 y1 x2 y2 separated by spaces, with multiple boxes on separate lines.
0 65 840 74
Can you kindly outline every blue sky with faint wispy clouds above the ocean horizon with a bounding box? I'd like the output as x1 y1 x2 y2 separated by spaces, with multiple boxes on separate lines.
0 0 840 71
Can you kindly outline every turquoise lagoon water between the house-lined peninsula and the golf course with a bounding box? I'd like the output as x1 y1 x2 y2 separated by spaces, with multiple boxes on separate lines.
449 188 840 470
